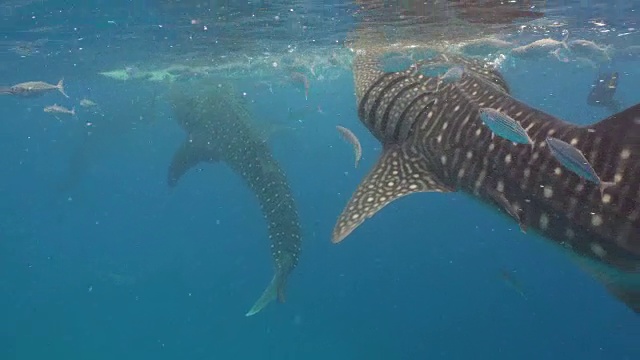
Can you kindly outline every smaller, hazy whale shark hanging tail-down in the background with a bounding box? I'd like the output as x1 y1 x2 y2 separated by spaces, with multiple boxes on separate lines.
168 84 301 316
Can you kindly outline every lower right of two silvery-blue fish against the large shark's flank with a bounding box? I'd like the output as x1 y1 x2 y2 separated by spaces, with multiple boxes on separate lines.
547 137 615 194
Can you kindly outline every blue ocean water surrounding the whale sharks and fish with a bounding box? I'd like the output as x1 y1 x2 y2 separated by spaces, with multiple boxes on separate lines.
0 0 640 360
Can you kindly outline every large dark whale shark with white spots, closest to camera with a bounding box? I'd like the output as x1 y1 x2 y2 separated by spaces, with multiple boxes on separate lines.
332 31 640 313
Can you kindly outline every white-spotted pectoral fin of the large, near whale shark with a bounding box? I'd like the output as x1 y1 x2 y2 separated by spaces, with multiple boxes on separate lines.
331 145 452 243
